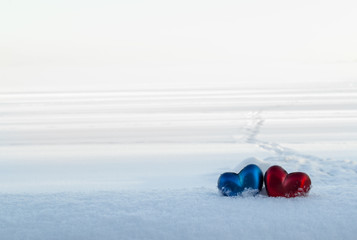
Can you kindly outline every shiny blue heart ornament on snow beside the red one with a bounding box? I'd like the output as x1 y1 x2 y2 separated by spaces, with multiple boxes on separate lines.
218 164 263 196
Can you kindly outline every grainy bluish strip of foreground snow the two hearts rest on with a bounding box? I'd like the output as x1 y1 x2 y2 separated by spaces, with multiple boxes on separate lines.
0 187 356 239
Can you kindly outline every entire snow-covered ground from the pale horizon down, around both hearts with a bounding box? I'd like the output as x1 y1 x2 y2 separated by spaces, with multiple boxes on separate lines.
0 87 357 240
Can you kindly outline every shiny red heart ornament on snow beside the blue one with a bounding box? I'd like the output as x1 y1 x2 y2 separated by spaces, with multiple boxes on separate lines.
264 166 311 198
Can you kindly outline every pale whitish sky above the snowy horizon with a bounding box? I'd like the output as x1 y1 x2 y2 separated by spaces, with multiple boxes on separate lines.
0 0 357 91
